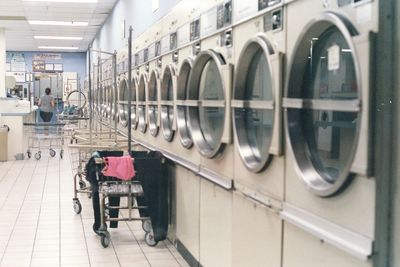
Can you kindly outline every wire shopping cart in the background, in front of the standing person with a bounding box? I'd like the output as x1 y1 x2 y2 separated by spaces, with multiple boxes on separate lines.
24 122 65 160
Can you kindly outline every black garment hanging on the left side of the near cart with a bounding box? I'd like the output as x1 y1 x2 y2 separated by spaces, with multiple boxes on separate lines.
86 151 124 231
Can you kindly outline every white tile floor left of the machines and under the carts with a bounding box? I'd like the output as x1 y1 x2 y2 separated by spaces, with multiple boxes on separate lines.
0 151 189 267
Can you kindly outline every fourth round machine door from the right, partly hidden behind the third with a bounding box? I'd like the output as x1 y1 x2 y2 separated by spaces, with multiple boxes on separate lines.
177 59 193 148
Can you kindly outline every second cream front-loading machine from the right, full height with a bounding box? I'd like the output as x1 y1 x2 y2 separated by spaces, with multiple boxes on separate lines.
231 0 286 267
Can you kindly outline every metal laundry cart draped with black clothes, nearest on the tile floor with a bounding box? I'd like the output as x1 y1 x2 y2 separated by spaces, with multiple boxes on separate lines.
88 151 168 248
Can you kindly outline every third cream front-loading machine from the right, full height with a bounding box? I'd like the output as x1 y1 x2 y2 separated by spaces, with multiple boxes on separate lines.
186 1 235 266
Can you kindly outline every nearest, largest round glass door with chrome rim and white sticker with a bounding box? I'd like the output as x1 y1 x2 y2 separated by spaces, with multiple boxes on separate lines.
284 13 361 196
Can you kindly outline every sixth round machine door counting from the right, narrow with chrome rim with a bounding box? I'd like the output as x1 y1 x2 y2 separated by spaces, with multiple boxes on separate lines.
147 70 160 136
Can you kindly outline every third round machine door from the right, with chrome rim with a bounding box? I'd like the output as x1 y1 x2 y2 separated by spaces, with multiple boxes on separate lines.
188 50 225 158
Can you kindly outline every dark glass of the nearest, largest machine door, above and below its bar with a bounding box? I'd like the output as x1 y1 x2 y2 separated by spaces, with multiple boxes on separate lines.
301 27 359 183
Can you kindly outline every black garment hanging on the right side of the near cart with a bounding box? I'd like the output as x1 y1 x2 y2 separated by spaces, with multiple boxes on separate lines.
131 151 168 244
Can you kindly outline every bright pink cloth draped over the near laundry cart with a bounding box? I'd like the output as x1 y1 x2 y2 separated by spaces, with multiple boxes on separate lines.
101 156 135 181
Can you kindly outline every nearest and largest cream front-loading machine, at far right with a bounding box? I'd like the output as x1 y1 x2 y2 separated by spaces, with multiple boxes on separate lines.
281 0 379 267
